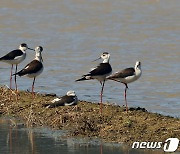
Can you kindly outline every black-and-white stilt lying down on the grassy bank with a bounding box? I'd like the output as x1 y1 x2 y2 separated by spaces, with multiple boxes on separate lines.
43 90 78 108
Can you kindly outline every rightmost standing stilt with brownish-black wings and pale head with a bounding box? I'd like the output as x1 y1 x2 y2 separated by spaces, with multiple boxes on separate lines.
106 61 142 112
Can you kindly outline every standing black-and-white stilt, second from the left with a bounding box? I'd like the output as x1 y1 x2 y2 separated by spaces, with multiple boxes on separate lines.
13 46 44 97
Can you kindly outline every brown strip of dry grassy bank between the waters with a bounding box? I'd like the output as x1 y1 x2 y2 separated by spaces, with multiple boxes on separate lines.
0 87 180 145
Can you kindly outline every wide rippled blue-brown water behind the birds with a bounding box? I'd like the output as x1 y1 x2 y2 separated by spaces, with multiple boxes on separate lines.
0 0 180 117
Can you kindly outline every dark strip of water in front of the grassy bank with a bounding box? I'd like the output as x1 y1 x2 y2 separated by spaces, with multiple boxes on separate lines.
0 118 166 154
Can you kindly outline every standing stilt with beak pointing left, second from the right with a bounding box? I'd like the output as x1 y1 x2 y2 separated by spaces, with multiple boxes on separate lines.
76 52 112 113
